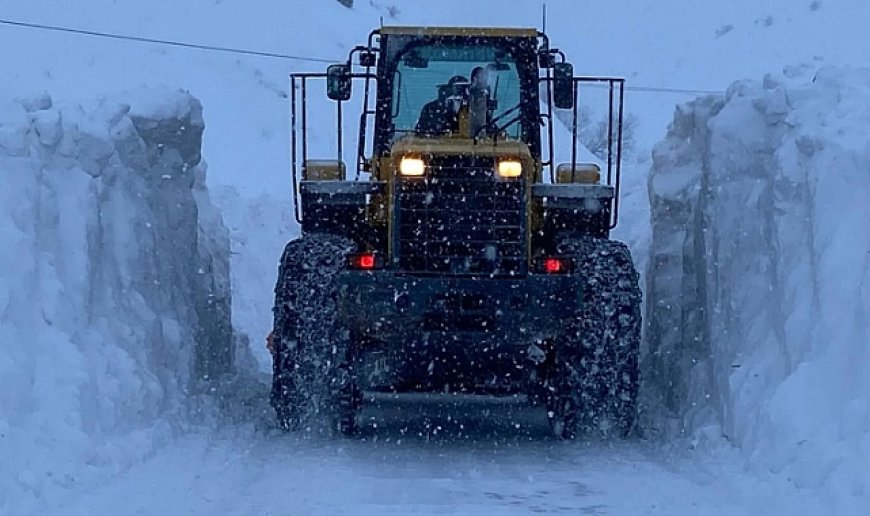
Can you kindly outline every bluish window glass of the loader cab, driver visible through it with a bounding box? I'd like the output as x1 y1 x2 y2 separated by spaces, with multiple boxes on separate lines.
392 43 521 139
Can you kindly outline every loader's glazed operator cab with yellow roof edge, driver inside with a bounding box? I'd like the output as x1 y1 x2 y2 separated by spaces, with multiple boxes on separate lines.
374 27 541 156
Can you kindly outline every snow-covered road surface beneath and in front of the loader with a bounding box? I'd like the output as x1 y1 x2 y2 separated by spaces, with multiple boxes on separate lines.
47 396 823 516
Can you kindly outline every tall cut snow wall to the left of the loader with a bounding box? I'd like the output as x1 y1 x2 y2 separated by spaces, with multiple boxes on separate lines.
0 87 232 514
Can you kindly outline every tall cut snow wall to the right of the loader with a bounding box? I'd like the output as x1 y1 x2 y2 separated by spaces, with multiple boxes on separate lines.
647 68 870 508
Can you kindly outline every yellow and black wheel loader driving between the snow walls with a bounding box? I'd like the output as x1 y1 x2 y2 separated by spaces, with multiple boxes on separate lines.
269 27 641 439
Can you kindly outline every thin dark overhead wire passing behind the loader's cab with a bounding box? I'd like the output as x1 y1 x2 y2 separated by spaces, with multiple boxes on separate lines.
0 18 722 95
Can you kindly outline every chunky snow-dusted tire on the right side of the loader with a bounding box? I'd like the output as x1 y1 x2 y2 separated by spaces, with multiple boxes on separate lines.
548 238 641 439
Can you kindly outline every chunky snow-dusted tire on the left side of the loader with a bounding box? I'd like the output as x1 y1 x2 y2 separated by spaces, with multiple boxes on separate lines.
271 233 361 433
